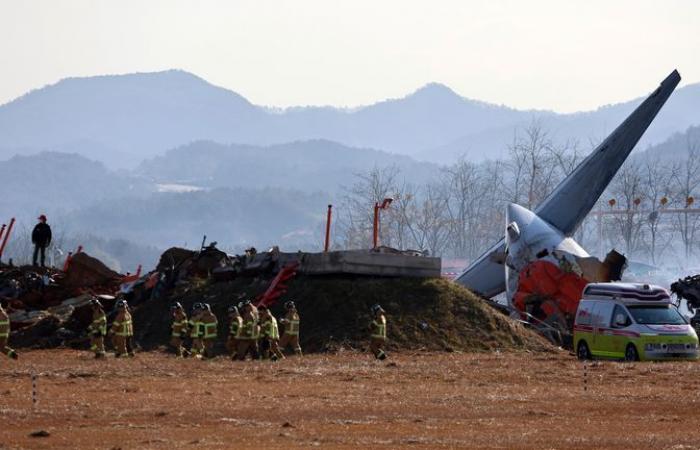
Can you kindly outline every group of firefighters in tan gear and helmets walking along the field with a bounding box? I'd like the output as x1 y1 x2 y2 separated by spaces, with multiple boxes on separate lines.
0 298 387 361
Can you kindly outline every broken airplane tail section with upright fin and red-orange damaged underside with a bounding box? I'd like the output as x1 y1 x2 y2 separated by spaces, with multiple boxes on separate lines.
456 70 681 342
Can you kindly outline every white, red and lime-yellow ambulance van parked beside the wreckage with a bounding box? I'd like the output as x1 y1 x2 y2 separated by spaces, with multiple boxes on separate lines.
574 283 698 361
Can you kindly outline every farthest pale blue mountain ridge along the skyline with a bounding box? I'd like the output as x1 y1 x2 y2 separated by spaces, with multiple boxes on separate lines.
0 70 700 168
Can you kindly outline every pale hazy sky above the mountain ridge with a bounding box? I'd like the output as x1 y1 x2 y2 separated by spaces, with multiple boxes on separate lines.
0 0 700 111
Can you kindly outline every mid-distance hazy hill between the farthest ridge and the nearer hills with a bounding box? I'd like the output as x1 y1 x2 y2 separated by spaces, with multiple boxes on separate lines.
135 140 440 193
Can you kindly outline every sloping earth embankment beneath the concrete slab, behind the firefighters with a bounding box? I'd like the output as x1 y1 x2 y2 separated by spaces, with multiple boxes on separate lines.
134 276 551 351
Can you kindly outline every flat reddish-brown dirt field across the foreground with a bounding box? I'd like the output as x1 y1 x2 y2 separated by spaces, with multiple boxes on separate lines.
0 350 700 450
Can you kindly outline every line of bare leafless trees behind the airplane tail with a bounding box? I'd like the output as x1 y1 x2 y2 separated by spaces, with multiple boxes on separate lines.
334 121 700 265
